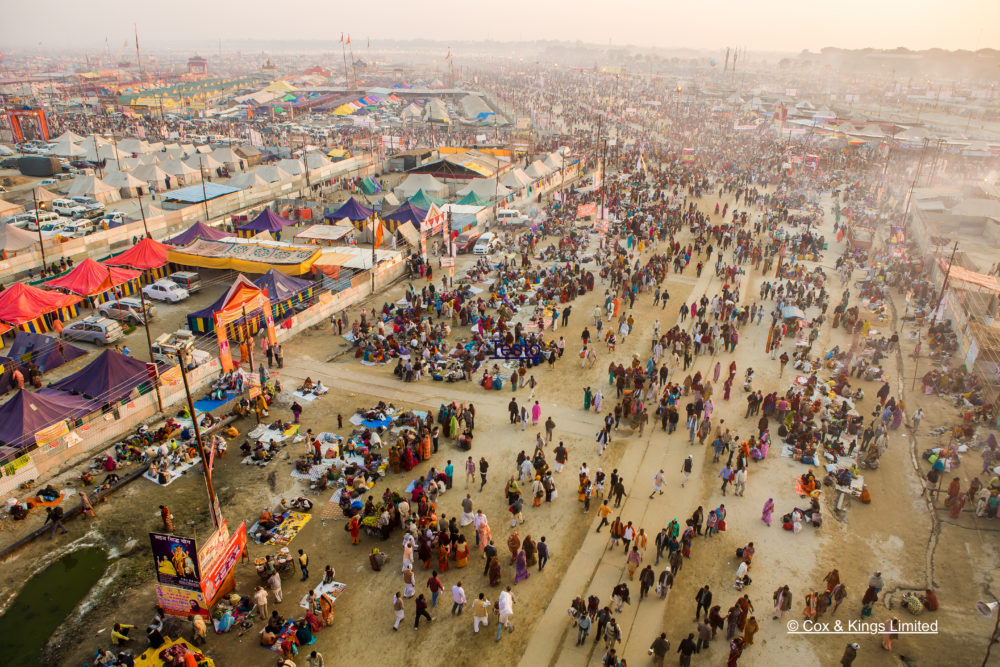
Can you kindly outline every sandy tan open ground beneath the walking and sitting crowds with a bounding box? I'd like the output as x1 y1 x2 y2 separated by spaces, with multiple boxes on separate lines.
0 184 998 665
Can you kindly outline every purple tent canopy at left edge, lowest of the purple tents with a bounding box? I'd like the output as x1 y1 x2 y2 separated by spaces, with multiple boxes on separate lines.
0 389 100 447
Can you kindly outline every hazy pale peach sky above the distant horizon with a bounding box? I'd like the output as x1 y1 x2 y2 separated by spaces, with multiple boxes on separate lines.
0 0 1000 55
